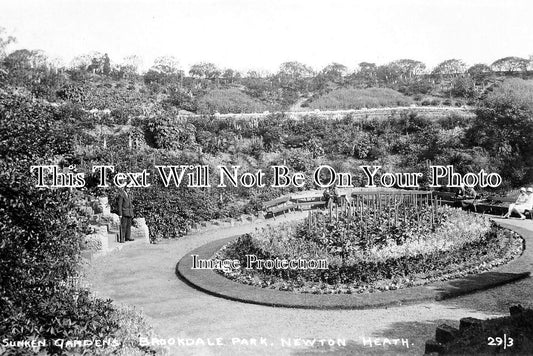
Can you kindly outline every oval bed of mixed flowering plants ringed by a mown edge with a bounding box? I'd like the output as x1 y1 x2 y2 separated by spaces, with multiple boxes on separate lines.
215 206 523 294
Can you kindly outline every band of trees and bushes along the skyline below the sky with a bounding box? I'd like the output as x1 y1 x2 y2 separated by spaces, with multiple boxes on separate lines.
0 25 533 113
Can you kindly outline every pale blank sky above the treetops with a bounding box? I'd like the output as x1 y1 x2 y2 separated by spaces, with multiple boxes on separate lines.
0 0 533 71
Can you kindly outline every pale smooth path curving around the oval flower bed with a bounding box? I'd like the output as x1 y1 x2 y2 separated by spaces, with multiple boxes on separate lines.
88 213 533 355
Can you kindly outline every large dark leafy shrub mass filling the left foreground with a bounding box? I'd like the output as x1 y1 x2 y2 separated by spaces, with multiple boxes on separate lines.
0 91 158 354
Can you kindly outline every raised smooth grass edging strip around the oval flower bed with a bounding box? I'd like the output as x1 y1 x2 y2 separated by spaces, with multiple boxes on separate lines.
176 222 533 309
